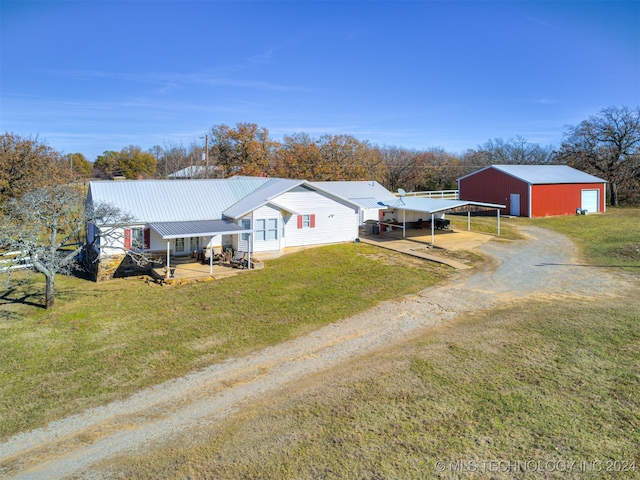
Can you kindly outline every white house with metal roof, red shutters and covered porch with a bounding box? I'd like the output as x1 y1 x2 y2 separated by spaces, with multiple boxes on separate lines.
87 177 360 279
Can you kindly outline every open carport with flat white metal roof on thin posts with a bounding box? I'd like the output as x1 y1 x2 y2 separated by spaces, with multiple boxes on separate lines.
379 196 505 245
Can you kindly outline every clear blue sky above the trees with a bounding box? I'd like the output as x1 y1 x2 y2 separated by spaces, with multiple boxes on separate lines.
0 0 640 161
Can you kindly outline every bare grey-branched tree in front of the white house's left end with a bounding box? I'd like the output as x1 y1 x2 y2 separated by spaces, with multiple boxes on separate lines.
0 185 140 308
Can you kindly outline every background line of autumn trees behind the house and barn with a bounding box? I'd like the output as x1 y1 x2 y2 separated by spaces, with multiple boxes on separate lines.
0 107 640 206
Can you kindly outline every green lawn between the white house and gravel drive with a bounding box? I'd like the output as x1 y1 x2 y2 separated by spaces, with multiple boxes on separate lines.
0 243 451 438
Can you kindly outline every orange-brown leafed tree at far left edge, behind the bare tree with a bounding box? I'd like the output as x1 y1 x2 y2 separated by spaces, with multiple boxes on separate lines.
0 133 73 204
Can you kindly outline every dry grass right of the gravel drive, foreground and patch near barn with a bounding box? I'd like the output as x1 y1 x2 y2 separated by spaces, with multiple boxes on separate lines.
101 209 640 479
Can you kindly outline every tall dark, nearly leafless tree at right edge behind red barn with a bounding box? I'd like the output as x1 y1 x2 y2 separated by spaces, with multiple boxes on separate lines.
557 107 640 206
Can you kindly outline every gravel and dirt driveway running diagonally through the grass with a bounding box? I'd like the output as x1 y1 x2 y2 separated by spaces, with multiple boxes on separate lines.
0 227 631 479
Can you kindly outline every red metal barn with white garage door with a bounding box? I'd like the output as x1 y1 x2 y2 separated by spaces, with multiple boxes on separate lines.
458 165 606 217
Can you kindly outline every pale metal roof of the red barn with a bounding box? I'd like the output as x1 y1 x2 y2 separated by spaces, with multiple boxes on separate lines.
458 165 605 185
